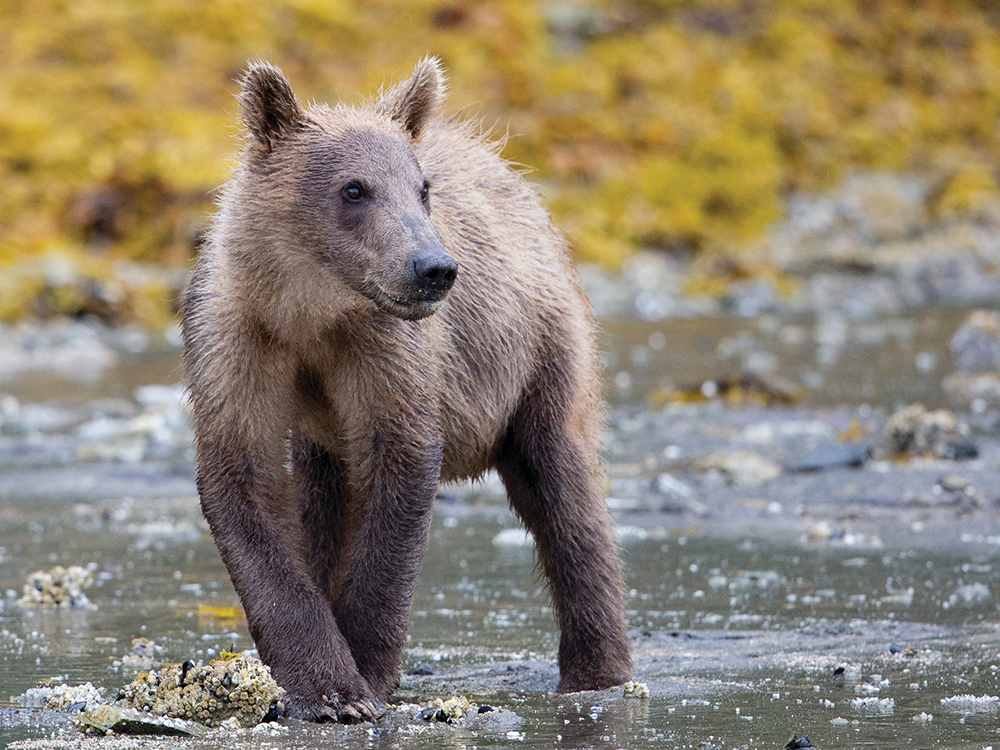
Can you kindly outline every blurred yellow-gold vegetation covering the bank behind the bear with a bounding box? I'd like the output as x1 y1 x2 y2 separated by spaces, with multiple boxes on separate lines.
0 0 1000 323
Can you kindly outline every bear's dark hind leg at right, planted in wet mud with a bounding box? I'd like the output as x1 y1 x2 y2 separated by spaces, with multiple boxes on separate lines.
496 346 632 692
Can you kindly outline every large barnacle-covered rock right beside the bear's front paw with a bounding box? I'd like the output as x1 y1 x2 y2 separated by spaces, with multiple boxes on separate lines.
121 651 285 727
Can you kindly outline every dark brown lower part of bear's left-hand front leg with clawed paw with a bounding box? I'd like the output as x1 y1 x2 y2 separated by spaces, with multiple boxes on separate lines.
198 432 378 723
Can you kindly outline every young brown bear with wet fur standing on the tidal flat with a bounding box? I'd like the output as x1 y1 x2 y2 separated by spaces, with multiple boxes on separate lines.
182 59 632 722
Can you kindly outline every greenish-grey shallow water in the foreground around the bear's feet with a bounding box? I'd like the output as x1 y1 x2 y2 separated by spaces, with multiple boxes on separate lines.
0 502 1000 748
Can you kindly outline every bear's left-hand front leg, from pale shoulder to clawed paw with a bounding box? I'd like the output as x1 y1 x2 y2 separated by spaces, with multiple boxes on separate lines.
184 328 377 722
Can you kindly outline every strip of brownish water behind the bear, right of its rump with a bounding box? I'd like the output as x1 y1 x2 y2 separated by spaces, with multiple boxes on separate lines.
601 310 967 409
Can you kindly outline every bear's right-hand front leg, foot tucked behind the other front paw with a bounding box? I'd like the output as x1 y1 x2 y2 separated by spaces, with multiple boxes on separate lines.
334 414 442 700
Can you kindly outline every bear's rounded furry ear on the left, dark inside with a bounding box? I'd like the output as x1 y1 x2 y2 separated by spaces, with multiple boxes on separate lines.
237 62 305 153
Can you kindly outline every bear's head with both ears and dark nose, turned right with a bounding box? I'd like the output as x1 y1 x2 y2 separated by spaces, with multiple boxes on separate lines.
239 58 458 320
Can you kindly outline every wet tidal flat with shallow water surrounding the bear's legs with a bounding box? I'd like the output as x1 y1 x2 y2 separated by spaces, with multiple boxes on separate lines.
0 313 1000 748
